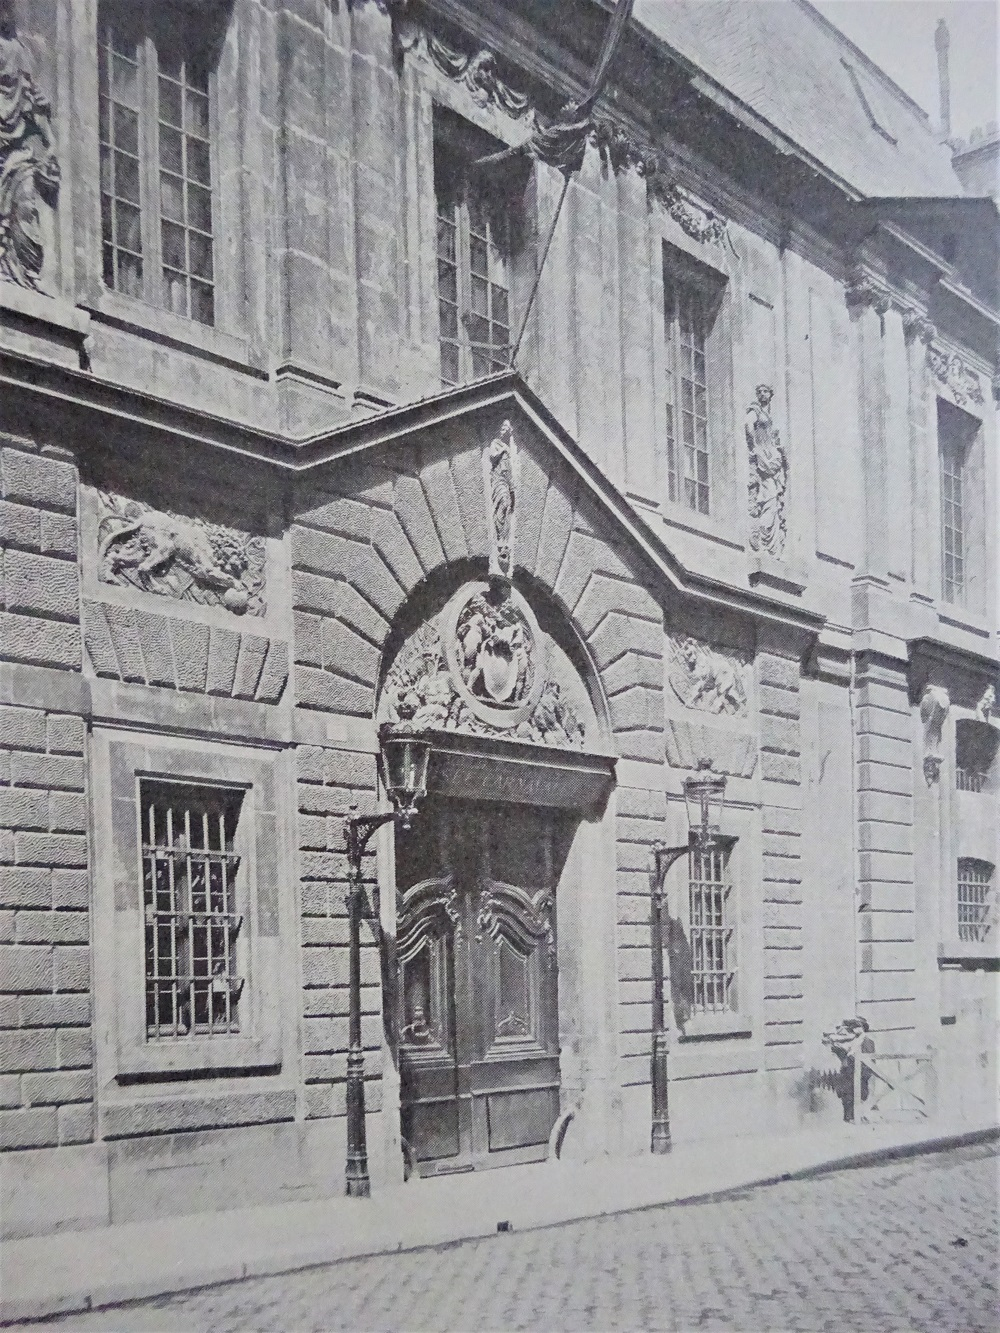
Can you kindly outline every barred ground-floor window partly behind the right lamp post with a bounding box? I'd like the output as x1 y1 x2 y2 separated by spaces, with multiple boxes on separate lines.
688 846 737 1013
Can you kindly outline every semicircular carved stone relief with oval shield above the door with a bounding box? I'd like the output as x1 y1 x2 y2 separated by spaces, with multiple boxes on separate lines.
381 583 585 749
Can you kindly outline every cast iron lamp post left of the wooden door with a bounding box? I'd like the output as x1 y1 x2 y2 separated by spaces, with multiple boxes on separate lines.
345 726 431 1198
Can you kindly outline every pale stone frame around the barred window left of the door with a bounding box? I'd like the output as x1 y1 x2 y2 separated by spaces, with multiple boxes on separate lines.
95 733 283 1082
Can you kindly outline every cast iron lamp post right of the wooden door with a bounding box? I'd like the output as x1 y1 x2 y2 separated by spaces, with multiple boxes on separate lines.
649 772 725 1154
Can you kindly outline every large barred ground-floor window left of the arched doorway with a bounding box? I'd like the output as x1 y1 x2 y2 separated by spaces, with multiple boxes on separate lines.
140 781 244 1040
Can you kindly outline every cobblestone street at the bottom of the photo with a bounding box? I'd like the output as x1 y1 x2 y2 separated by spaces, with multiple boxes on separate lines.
35 1144 1000 1333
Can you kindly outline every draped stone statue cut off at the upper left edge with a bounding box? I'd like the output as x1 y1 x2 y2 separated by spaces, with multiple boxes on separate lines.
0 0 59 291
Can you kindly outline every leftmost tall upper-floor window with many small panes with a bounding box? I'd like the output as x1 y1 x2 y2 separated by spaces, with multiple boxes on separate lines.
99 0 216 324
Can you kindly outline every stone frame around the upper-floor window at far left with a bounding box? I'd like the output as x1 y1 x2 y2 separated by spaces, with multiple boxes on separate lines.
73 0 256 371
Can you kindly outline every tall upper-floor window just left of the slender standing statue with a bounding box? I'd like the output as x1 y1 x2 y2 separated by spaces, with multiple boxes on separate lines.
663 248 720 513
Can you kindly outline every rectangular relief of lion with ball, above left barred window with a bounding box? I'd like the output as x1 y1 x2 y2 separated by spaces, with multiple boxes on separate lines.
97 495 265 616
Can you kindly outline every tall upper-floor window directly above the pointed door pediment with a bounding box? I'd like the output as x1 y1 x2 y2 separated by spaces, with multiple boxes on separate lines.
435 112 516 385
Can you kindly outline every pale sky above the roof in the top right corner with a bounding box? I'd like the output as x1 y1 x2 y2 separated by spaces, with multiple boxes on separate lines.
812 0 1000 136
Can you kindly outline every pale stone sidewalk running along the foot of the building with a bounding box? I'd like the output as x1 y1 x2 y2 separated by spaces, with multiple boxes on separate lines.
0 1121 1000 1322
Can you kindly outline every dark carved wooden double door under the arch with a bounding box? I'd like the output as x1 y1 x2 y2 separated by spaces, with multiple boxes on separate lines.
396 800 568 1174
